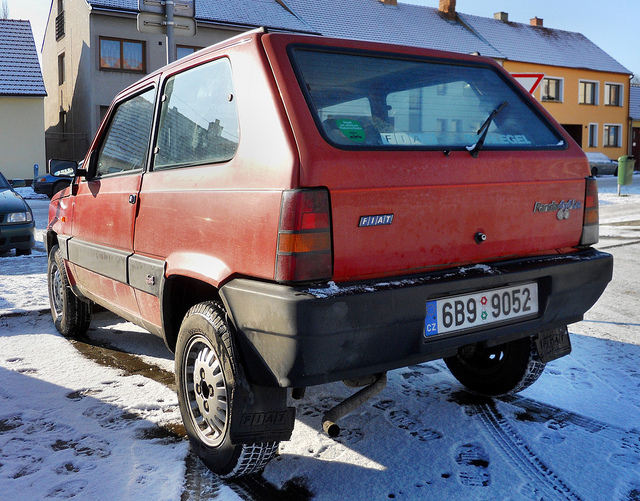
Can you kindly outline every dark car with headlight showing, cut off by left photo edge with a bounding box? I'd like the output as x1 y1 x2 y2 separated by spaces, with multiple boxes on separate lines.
0 173 36 256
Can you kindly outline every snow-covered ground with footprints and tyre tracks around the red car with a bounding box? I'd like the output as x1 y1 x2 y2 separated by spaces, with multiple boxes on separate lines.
0 181 640 501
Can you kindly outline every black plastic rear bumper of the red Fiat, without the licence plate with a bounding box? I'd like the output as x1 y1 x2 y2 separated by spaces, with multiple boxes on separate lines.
220 249 613 387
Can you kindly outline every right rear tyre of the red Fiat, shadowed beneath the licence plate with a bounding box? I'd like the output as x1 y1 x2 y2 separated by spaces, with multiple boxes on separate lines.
444 337 545 396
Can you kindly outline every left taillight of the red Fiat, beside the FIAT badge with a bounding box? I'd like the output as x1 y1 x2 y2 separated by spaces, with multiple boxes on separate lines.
275 188 332 282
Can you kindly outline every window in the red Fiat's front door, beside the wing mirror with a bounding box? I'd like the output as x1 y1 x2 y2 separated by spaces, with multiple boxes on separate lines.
96 89 155 176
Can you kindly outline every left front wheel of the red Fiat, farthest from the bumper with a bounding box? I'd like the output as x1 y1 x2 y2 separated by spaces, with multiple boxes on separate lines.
47 245 91 337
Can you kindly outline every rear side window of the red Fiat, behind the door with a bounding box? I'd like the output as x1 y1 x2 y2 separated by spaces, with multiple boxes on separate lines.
154 59 240 170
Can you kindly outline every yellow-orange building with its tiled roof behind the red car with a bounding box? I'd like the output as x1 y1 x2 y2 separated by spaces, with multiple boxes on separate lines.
459 12 632 160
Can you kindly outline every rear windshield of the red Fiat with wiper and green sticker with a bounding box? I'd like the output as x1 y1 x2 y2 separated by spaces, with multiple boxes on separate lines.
291 47 566 150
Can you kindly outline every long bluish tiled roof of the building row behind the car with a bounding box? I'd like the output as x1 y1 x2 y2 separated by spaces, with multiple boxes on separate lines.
88 0 631 74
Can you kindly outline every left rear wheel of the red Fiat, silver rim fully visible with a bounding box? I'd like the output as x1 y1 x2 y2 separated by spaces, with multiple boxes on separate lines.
176 301 279 478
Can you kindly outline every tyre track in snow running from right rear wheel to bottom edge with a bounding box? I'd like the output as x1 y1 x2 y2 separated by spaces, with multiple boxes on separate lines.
473 402 582 501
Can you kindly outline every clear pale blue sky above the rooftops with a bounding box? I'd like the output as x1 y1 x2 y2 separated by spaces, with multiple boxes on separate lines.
3 0 640 75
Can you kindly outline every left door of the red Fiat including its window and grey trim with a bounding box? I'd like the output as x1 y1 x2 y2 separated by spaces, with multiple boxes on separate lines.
67 85 156 318
